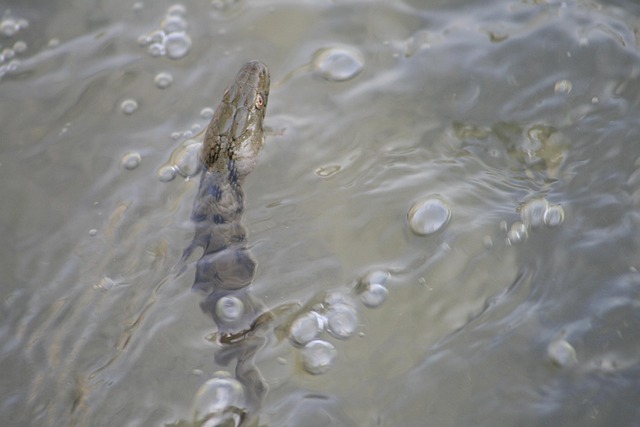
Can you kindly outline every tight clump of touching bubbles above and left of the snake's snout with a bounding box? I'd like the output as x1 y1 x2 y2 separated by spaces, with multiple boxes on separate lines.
138 4 191 59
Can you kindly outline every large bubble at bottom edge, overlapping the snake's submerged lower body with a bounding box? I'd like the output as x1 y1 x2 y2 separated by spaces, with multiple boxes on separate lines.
192 372 245 425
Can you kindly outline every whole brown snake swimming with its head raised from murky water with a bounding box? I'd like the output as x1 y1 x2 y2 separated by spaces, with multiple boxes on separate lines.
182 61 270 425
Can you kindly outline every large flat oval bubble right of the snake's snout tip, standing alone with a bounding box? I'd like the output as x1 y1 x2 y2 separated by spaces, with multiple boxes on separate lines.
311 47 364 82
